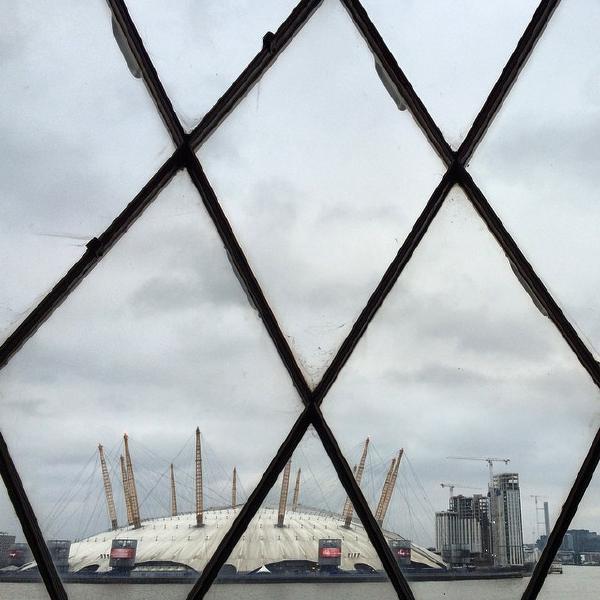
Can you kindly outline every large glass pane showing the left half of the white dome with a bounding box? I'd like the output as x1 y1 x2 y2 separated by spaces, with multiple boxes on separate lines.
0 174 302 596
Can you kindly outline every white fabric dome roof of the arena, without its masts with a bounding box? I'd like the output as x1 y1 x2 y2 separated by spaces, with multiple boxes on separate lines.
69 507 444 572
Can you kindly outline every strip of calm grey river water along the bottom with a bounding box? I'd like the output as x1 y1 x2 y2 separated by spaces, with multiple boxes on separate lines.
0 567 600 600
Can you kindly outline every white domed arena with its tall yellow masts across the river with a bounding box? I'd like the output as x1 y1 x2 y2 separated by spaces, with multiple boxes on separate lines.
59 429 445 574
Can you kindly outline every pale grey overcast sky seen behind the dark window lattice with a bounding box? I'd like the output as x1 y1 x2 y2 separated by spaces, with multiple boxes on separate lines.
0 0 600 560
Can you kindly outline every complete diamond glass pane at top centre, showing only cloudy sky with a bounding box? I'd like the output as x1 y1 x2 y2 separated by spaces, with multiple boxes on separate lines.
200 0 444 384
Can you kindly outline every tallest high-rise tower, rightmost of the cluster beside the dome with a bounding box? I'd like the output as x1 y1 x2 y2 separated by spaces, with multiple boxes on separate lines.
489 473 525 566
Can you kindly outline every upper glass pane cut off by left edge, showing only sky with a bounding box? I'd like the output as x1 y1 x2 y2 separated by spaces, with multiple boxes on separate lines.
0 0 171 340
